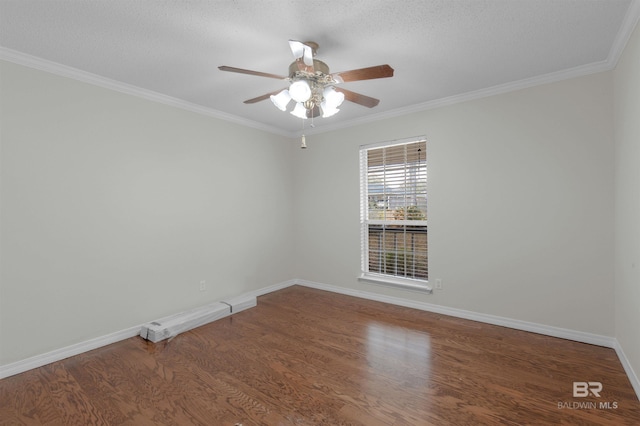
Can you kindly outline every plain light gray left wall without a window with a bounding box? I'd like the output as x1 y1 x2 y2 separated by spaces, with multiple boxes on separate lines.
0 62 292 365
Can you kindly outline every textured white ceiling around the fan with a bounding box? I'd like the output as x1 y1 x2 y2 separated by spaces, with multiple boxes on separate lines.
0 0 640 135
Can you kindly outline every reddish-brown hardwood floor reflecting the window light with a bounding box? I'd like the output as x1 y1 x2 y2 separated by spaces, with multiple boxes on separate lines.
0 286 640 426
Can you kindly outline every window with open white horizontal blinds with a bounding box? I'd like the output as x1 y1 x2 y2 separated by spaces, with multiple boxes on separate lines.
360 138 429 290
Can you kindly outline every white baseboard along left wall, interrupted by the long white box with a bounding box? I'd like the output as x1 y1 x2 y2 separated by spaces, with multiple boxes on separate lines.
0 280 296 379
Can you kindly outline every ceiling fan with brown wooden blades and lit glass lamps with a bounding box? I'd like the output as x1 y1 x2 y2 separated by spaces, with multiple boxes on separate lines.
218 40 393 119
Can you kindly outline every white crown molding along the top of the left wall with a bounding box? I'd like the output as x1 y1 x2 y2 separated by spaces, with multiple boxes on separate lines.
0 46 290 136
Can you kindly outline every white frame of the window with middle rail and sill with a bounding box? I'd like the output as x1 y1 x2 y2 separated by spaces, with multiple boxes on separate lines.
358 136 433 293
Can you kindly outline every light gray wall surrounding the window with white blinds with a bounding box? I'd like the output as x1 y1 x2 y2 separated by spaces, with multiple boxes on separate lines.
292 73 614 336
